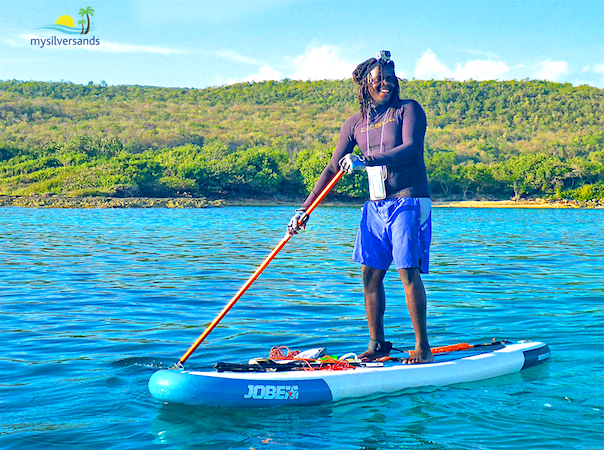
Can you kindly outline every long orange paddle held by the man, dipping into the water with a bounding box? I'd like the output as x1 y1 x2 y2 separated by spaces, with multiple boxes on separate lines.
172 170 344 369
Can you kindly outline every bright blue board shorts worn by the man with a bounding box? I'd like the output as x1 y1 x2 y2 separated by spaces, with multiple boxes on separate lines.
352 198 432 273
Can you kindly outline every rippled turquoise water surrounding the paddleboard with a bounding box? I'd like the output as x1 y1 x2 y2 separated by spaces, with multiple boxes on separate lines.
0 207 604 450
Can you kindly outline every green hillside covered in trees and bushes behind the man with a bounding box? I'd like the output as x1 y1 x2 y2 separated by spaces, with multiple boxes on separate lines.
0 80 604 200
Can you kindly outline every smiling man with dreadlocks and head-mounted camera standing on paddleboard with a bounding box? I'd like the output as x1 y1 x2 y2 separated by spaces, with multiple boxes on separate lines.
287 51 434 364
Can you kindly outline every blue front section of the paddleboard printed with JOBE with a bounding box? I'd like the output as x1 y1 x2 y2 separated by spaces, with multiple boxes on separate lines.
149 370 332 407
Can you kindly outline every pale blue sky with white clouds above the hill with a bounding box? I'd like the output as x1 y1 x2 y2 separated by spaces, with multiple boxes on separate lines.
0 0 604 88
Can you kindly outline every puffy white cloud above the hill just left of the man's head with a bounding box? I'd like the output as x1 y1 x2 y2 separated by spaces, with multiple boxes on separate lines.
290 45 356 80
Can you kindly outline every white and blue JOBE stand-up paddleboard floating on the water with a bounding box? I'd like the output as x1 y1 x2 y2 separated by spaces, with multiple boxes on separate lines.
149 341 550 407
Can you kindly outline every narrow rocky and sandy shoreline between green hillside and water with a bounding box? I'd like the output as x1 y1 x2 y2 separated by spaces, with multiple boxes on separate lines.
0 195 604 209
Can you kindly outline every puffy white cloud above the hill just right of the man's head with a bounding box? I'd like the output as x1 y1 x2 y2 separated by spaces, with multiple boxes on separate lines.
414 50 510 81
